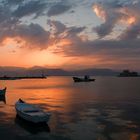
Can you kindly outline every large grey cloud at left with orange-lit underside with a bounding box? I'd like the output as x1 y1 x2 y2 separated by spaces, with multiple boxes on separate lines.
0 8 50 49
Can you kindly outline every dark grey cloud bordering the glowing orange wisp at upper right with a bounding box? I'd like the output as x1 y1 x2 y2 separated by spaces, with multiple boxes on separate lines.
93 1 122 37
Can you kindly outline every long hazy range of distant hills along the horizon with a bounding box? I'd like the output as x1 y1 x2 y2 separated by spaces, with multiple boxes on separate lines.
0 66 119 77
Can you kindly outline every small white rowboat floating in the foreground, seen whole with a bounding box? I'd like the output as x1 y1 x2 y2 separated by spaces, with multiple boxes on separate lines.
15 99 51 123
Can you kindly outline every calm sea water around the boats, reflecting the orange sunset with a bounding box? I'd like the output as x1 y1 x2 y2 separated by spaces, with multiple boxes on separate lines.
0 77 140 140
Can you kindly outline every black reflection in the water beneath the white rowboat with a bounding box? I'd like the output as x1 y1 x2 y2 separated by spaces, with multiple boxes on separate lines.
15 115 50 134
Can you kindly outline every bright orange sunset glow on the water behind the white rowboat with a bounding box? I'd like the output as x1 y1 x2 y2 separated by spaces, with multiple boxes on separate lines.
1 77 85 120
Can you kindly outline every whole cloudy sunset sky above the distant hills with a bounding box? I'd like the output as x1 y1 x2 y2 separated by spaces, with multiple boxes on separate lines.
0 0 140 70
